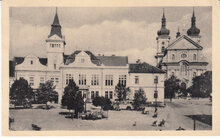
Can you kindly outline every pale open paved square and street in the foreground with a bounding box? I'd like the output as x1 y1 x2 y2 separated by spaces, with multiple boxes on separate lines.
10 99 212 130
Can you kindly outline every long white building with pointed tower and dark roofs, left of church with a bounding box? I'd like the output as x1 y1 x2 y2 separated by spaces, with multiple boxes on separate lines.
10 10 165 102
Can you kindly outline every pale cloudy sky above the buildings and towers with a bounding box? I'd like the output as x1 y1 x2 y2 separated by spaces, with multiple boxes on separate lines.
10 7 212 69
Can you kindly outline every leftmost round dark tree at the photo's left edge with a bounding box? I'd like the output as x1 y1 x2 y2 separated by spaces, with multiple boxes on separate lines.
9 78 34 108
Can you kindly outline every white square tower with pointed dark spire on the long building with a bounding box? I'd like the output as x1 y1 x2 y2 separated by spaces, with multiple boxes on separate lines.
46 9 66 70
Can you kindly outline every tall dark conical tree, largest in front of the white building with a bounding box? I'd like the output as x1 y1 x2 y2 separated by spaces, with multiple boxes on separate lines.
61 80 84 117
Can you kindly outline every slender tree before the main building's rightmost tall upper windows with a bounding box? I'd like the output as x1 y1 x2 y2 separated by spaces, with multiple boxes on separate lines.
115 83 130 101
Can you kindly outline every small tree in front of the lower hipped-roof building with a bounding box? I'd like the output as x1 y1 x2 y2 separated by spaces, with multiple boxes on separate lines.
133 88 147 110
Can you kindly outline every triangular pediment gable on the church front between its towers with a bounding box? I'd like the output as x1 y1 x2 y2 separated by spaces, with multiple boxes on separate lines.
167 35 203 50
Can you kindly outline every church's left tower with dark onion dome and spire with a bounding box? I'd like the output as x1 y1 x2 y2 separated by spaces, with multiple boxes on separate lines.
155 9 170 67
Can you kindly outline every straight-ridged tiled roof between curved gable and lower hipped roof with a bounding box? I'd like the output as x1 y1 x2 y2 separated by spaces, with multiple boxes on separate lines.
97 56 128 66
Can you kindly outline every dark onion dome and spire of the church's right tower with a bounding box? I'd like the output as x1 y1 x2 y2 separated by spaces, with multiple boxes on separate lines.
187 8 201 43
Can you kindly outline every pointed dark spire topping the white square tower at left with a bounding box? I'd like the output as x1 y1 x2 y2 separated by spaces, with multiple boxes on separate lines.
48 7 62 38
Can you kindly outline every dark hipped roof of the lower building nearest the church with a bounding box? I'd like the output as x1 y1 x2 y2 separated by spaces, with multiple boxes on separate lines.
129 62 165 73
